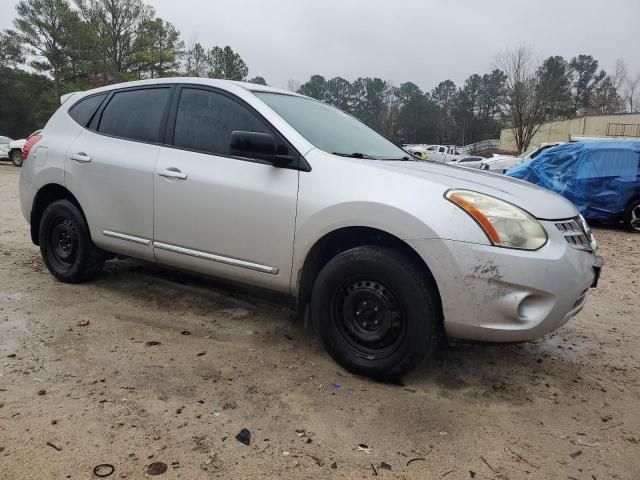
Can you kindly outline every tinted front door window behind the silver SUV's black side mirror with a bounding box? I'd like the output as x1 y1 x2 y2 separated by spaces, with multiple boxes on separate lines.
173 88 272 155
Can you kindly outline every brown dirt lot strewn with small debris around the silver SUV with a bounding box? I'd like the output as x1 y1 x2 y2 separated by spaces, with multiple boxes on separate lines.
0 163 640 480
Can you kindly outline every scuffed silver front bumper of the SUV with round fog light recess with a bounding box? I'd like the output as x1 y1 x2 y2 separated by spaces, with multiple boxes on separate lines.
409 221 601 342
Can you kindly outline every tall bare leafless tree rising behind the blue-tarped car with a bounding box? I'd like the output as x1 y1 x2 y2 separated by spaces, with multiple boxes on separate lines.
495 46 546 152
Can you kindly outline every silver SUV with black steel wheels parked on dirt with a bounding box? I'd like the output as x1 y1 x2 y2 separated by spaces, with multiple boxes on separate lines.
20 78 600 378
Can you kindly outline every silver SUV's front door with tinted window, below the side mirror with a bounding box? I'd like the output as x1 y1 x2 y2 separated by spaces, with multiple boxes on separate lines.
154 86 298 291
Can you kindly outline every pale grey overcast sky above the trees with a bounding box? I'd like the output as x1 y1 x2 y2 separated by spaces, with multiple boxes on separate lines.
0 0 640 90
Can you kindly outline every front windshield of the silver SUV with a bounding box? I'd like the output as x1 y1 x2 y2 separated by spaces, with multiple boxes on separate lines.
254 92 407 160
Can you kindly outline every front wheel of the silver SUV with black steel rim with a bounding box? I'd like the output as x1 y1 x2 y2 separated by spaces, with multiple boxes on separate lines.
311 246 442 379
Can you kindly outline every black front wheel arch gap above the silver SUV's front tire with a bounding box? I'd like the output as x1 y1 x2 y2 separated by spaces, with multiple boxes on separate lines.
293 226 442 316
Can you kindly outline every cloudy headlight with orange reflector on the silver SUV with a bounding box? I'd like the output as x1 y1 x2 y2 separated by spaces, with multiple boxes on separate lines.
445 190 547 250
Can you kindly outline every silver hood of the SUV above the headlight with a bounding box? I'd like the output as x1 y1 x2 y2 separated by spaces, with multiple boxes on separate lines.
368 161 578 220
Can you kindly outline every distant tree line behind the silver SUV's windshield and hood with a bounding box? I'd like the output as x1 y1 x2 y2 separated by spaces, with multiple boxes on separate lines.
298 47 640 151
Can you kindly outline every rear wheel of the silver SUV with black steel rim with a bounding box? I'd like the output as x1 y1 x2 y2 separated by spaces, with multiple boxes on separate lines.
40 200 104 283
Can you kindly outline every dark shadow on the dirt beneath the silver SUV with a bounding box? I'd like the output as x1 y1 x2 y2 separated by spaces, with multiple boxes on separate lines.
84 259 580 402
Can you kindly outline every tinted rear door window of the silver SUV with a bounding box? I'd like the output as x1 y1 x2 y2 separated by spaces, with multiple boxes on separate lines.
98 88 171 143
